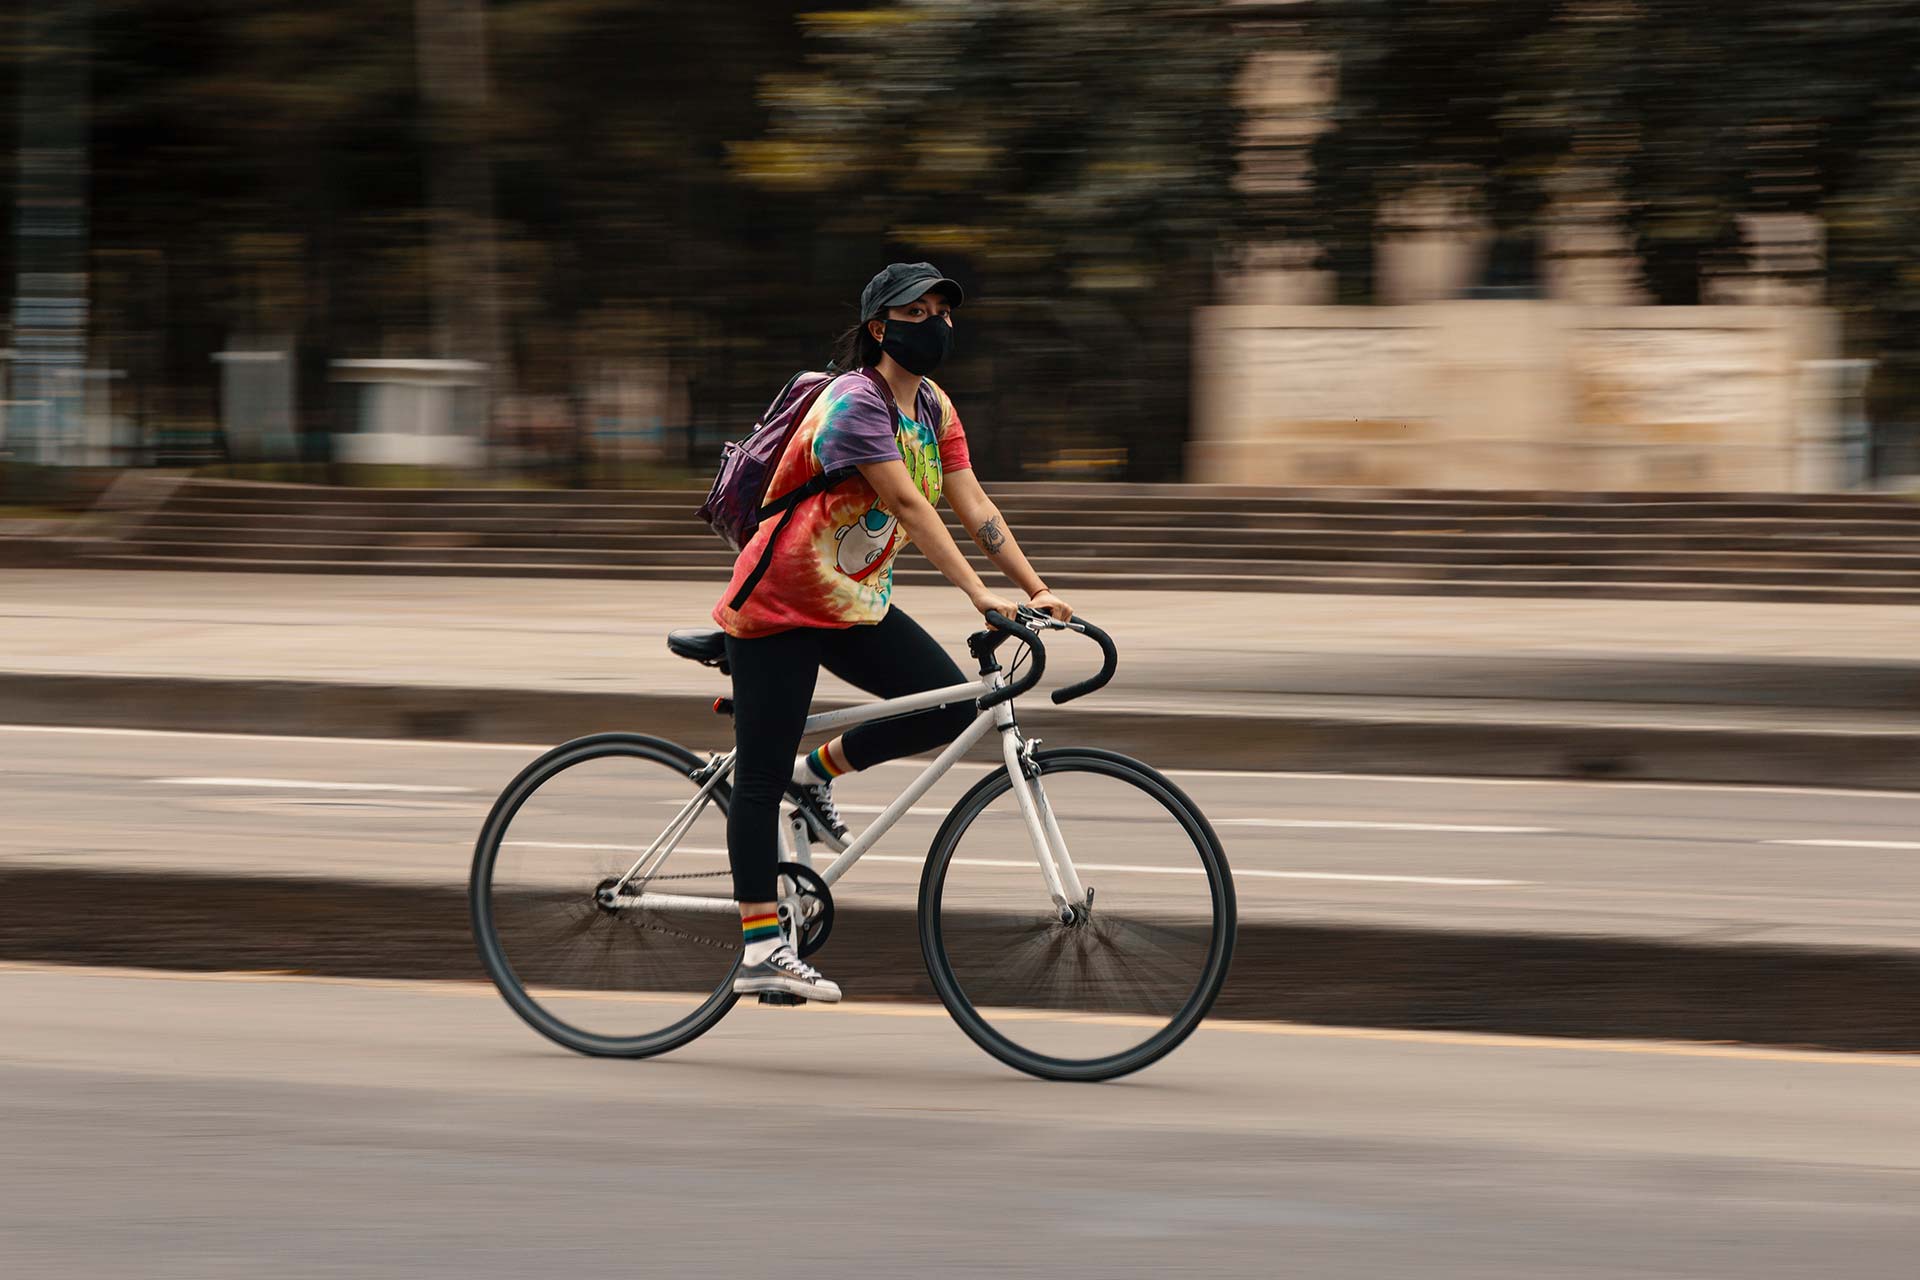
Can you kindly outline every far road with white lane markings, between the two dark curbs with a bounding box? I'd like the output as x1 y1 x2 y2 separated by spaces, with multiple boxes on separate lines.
11 725 1920 946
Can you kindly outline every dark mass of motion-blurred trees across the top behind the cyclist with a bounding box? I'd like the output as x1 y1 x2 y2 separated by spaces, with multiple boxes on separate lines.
37 0 1920 478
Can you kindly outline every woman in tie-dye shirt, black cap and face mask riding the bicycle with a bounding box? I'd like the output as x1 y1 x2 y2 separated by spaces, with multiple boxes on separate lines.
712 263 1073 1002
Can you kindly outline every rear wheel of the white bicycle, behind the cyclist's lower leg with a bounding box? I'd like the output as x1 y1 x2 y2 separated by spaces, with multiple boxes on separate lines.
468 733 741 1057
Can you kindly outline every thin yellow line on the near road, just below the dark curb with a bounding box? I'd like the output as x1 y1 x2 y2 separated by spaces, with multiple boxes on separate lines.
0 961 1920 1069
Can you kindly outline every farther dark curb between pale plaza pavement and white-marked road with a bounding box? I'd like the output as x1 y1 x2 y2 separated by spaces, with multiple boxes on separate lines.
0 672 1920 789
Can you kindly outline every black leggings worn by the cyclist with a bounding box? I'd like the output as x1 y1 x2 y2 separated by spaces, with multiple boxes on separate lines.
726 608 973 902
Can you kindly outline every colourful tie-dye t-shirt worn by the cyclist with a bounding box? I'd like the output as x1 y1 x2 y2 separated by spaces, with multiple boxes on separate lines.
714 372 972 639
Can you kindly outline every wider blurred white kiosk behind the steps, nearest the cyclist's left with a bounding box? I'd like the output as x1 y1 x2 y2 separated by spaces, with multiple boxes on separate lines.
334 361 488 466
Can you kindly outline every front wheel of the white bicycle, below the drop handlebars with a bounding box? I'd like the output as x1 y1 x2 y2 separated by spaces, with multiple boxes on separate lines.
920 748 1235 1080
